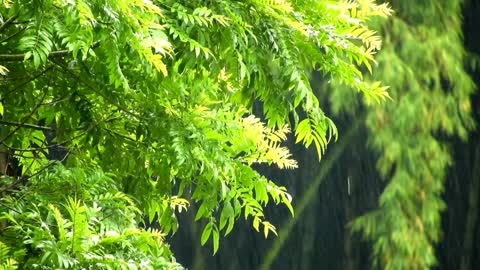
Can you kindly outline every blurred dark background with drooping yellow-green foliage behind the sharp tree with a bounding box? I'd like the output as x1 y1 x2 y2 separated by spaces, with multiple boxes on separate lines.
171 0 480 270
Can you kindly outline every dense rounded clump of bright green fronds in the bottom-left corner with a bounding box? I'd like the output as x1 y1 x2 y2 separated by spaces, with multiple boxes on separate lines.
0 165 181 269
